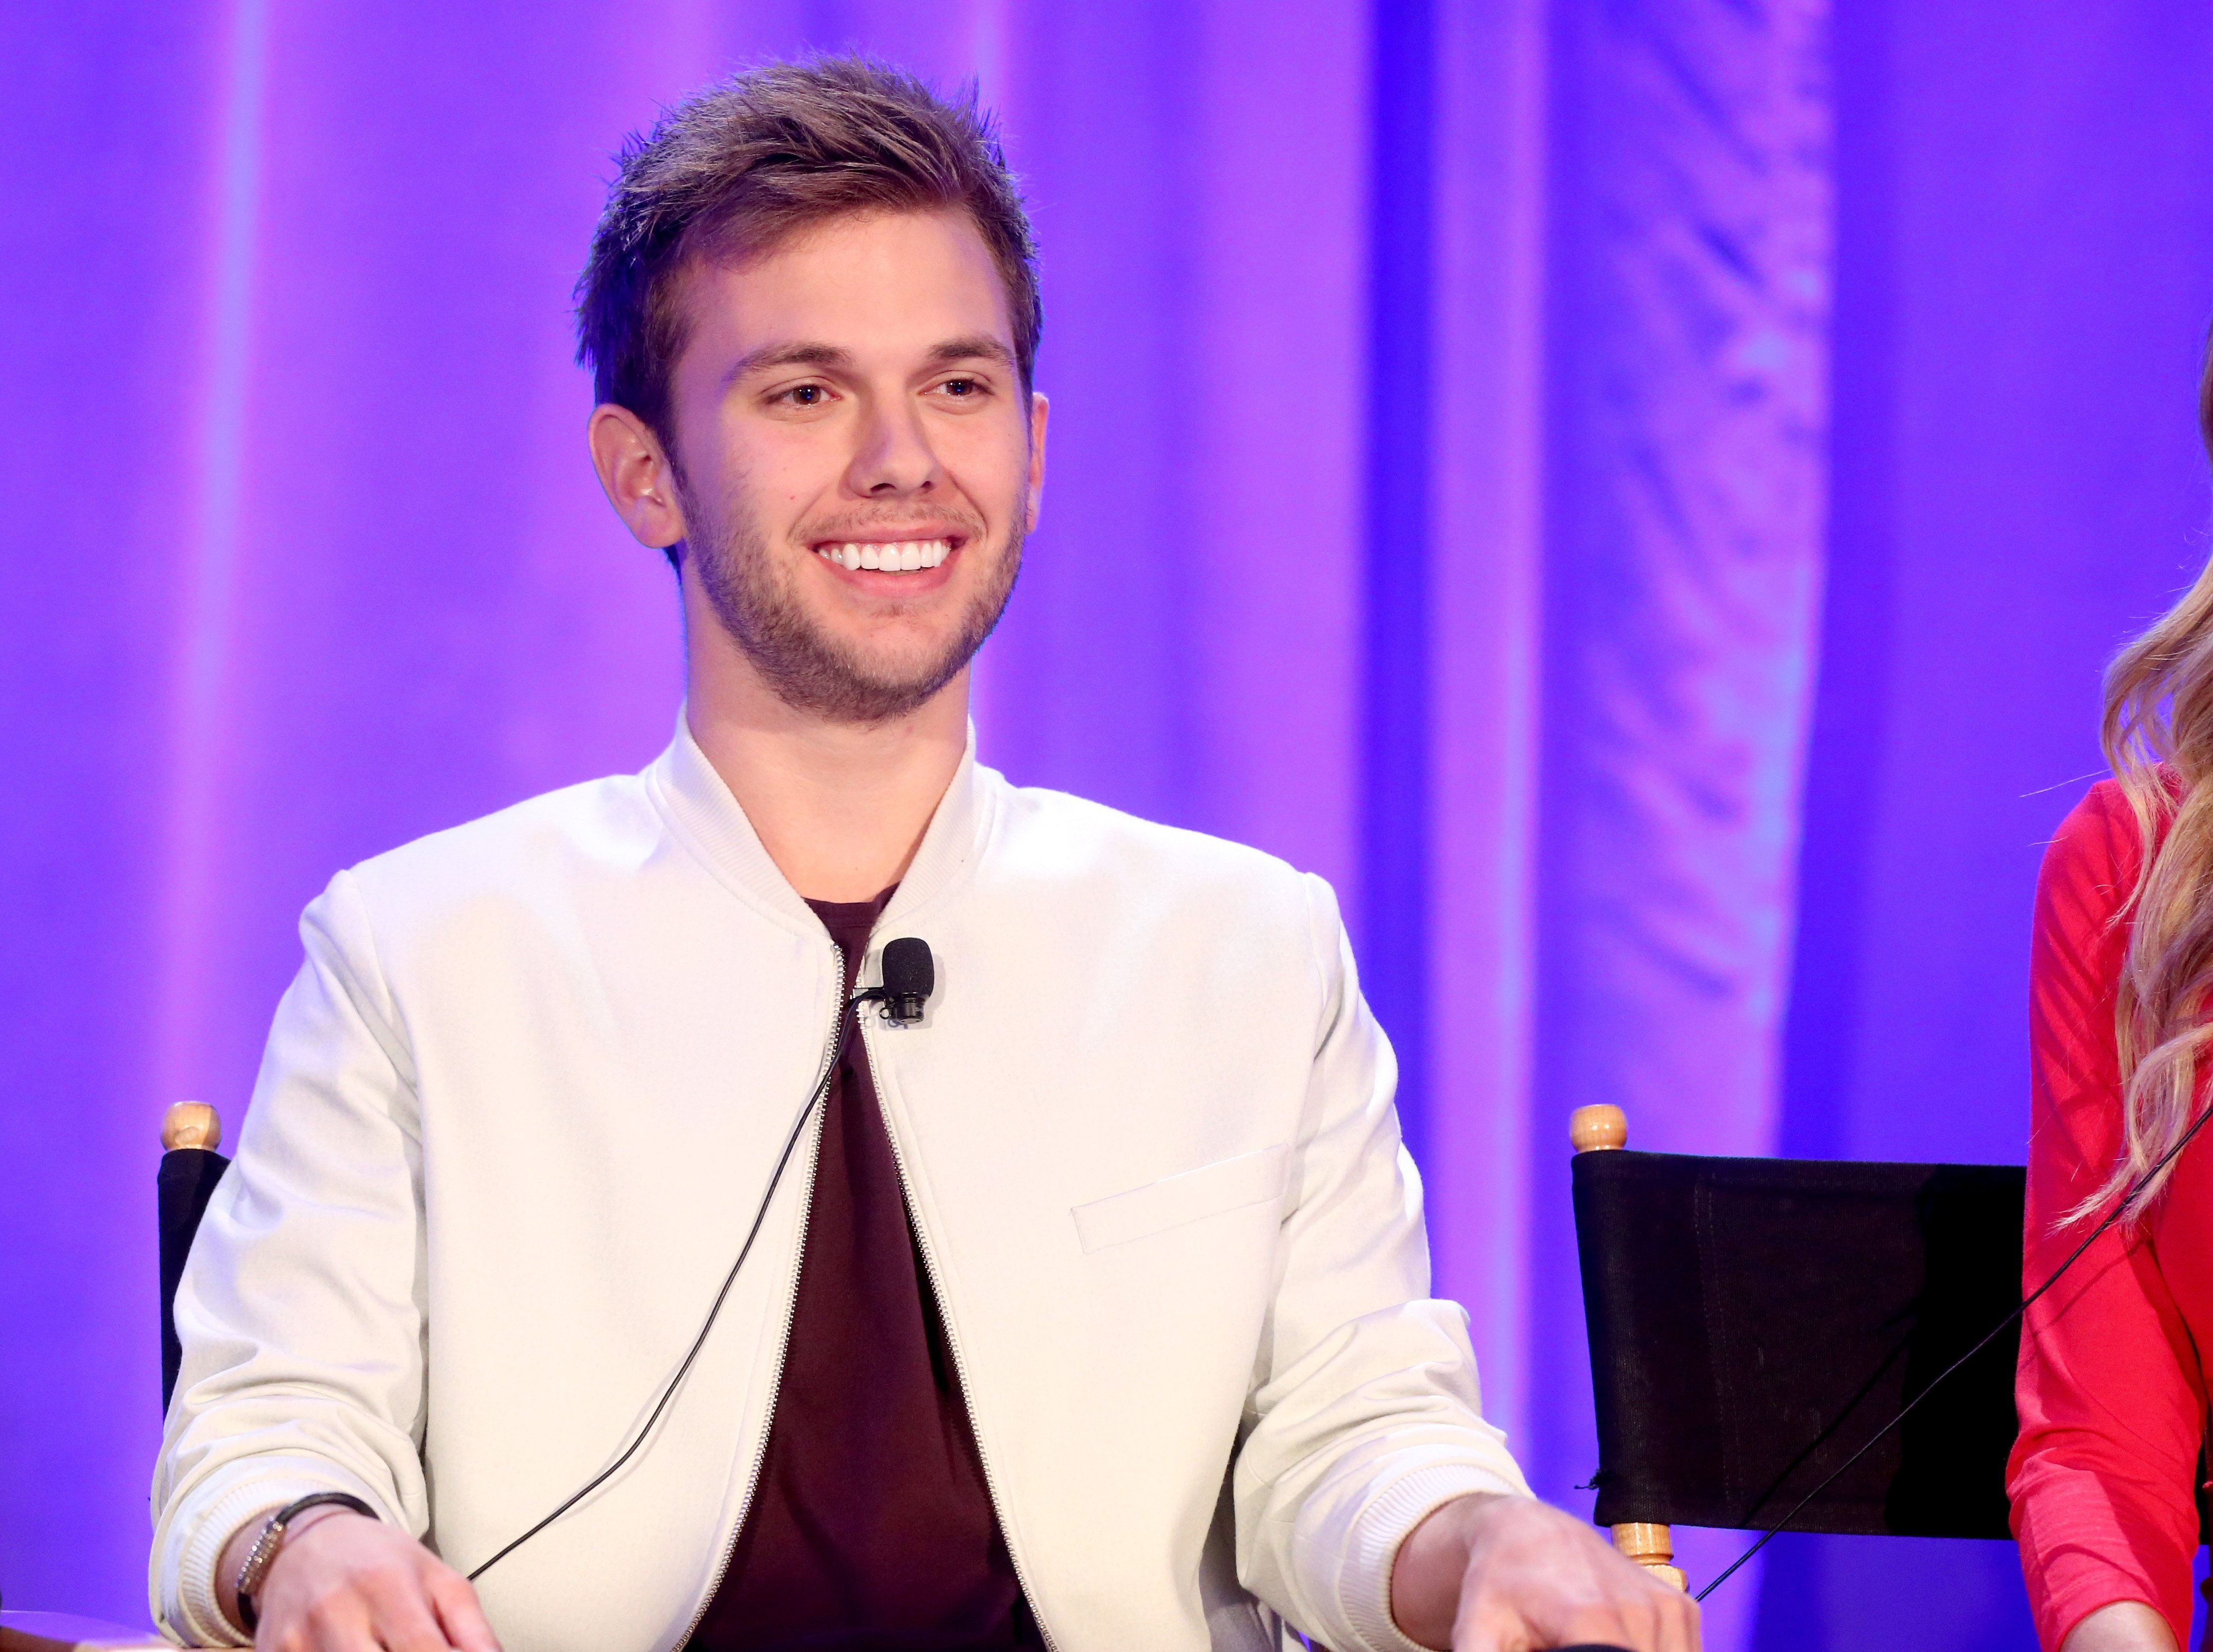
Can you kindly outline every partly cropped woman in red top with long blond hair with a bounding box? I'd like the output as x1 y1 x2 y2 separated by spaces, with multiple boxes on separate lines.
2007 338 2213 1652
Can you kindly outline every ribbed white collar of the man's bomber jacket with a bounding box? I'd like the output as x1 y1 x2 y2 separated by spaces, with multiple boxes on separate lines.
646 709 998 934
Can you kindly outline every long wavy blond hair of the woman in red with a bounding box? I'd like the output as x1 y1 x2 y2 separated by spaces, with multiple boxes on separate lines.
2074 336 2213 1218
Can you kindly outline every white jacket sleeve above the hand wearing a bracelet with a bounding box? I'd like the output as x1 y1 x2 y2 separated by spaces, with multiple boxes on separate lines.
153 872 429 1643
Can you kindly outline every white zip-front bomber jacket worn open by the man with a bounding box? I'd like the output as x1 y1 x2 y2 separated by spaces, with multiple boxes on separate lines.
150 726 1527 1652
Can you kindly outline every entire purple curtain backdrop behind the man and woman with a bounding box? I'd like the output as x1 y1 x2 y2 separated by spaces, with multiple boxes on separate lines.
0 0 2213 1652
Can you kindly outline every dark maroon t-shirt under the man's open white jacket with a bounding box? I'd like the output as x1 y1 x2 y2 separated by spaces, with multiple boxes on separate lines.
691 890 1044 1652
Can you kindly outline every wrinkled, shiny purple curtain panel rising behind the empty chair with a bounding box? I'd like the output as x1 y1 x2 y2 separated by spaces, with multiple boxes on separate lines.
1527 0 1832 1646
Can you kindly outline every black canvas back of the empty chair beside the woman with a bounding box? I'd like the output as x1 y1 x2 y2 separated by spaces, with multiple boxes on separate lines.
1574 1107 2025 1537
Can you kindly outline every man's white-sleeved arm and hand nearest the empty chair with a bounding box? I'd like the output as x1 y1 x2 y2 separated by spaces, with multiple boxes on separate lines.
1233 879 1698 1652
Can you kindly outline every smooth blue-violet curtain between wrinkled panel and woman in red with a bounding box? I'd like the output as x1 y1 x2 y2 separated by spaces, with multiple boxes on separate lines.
1757 0 2213 1652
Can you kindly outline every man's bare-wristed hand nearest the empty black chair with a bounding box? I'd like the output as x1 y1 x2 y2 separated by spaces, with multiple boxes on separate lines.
1390 1497 1698 1652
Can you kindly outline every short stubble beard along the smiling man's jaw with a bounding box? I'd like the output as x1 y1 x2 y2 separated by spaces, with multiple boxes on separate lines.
686 485 1022 724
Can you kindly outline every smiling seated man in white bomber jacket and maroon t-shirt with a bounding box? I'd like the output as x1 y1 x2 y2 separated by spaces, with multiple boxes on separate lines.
153 60 1698 1652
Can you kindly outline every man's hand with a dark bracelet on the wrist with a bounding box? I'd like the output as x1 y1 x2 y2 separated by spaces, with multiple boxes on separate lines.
214 1508 500 1652
